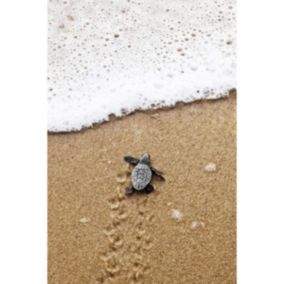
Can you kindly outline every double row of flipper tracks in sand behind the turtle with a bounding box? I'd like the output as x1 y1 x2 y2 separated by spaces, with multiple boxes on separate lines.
96 171 154 284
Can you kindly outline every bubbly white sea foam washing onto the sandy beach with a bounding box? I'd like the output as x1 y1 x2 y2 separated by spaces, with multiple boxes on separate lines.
48 0 236 132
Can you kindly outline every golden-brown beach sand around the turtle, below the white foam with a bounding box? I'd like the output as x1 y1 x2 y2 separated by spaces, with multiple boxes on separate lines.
48 94 236 284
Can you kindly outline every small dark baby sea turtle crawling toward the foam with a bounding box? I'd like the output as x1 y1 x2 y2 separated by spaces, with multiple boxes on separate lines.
124 153 165 195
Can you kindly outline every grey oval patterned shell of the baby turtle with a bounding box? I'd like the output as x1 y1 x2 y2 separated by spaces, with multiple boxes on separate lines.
131 164 152 190
